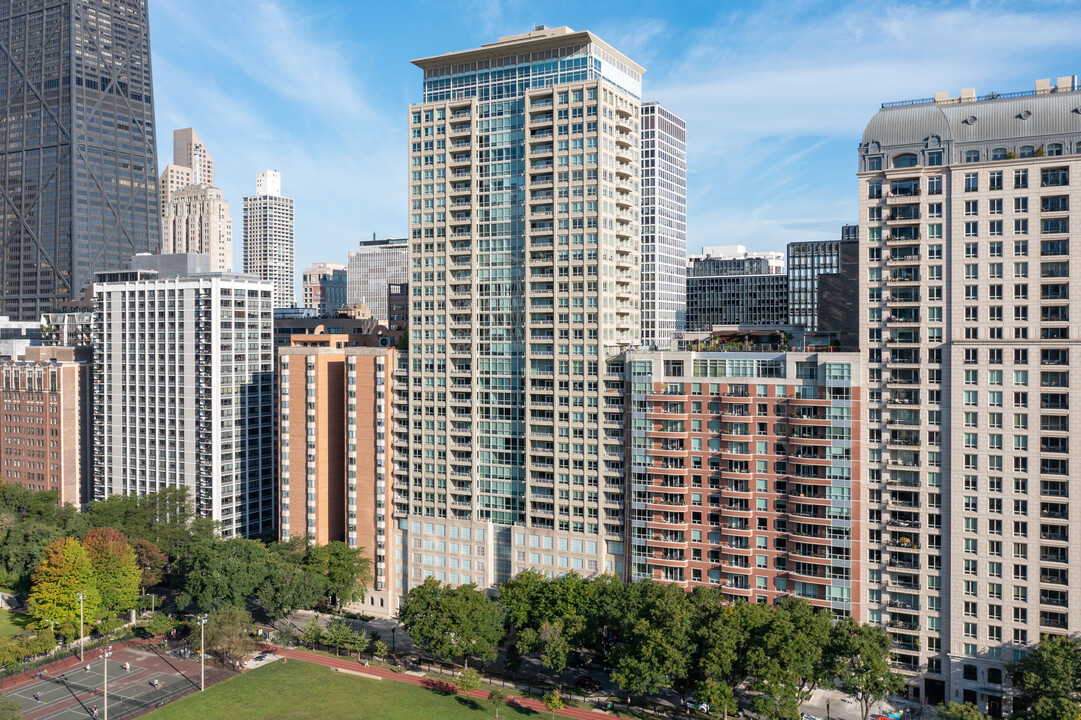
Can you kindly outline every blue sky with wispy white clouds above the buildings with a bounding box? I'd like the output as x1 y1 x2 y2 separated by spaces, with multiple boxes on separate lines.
150 0 1081 275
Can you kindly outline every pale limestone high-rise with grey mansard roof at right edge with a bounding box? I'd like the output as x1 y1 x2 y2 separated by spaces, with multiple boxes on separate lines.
858 77 1081 718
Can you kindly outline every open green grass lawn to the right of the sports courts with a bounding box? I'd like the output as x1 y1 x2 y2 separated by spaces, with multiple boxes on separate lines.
146 662 537 720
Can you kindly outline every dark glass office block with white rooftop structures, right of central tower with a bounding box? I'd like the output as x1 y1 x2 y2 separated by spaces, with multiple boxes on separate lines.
686 245 788 332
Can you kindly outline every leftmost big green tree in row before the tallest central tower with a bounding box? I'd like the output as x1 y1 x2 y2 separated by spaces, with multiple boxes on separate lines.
398 577 504 667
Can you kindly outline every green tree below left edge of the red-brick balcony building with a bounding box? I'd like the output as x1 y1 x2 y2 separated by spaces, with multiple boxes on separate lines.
612 579 693 695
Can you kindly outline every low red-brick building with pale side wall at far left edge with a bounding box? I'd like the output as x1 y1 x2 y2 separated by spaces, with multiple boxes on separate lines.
0 347 91 507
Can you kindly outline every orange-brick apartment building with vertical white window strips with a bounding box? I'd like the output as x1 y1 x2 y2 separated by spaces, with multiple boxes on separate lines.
278 335 398 615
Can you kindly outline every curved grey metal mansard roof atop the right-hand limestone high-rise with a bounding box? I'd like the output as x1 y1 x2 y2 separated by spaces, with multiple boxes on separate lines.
863 92 1081 148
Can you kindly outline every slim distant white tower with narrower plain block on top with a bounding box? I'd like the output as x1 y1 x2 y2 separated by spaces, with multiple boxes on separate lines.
244 170 296 307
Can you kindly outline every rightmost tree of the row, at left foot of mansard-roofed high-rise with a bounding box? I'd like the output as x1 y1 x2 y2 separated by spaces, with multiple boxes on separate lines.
827 617 905 720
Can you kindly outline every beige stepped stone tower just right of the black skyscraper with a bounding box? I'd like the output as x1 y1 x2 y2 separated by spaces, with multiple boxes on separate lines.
159 128 232 272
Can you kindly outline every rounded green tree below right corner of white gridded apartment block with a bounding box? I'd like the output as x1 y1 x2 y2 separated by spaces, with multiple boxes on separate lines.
184 537 267 610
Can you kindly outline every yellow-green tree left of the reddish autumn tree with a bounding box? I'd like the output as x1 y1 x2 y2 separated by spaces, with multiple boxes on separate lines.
26 537 102 635
